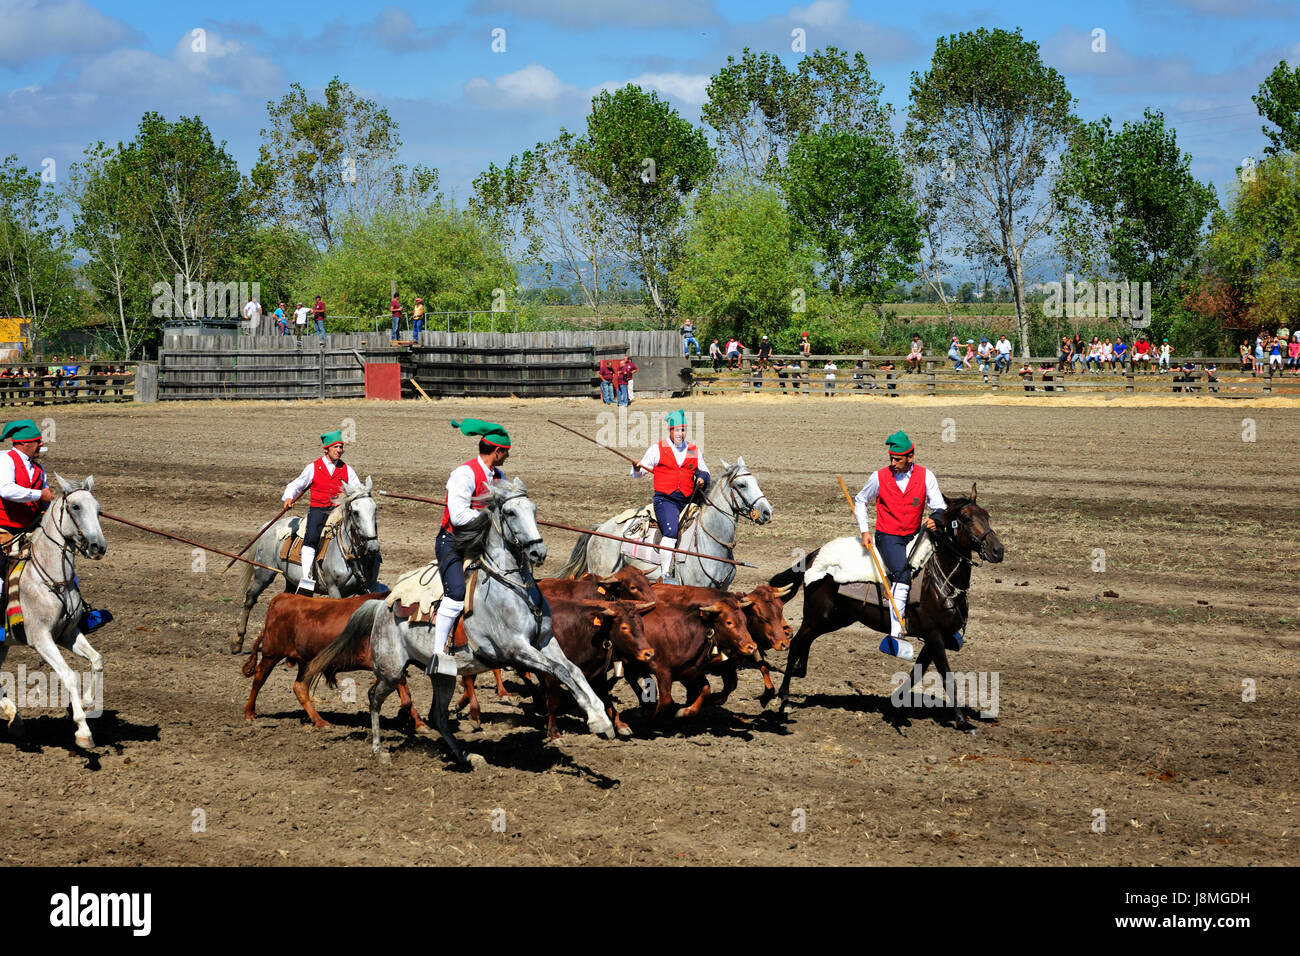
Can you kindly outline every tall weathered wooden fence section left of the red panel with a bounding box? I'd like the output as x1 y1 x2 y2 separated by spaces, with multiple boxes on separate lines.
159 332 402 399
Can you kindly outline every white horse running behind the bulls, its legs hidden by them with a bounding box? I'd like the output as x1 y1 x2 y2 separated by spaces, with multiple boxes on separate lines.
559 457 772 591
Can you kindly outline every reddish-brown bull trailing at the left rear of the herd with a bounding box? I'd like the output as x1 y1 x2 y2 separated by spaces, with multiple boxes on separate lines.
241 593 425 730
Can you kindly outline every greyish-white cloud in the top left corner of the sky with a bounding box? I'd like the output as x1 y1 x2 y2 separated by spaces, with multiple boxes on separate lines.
0 0 133 66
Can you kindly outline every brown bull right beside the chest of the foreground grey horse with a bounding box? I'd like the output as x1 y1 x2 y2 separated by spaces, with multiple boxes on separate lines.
542 597 655 740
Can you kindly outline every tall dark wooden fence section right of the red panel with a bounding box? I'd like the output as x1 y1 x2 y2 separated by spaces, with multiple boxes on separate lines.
403 332 681 398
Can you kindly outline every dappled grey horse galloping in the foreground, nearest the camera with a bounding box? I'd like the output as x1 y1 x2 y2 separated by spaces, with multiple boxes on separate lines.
303 477 614 765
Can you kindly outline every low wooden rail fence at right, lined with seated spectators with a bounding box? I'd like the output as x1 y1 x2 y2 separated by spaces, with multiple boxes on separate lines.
692 355 1300 398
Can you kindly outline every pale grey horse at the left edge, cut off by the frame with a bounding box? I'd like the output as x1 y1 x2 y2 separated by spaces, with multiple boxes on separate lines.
0 475 108 749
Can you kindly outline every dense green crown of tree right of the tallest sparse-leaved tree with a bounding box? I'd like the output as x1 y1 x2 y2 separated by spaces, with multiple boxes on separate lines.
1056 109 1217 312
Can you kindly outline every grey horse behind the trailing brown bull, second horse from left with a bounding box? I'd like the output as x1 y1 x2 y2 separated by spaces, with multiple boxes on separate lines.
230 477 380 654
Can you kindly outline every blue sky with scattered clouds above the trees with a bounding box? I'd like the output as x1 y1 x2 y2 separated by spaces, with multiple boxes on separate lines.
0 0 1300 208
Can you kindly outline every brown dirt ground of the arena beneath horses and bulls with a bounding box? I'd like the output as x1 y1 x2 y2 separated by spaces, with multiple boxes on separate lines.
0 395 1300 865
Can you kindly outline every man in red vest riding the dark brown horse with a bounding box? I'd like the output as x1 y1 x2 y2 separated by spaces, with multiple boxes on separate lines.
853 432 948 661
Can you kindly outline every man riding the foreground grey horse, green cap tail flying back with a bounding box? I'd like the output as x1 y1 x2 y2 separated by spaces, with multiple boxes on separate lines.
428 419 510 676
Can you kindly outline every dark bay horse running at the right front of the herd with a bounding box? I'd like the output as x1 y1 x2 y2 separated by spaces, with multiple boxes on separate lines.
770 485 1004 731
